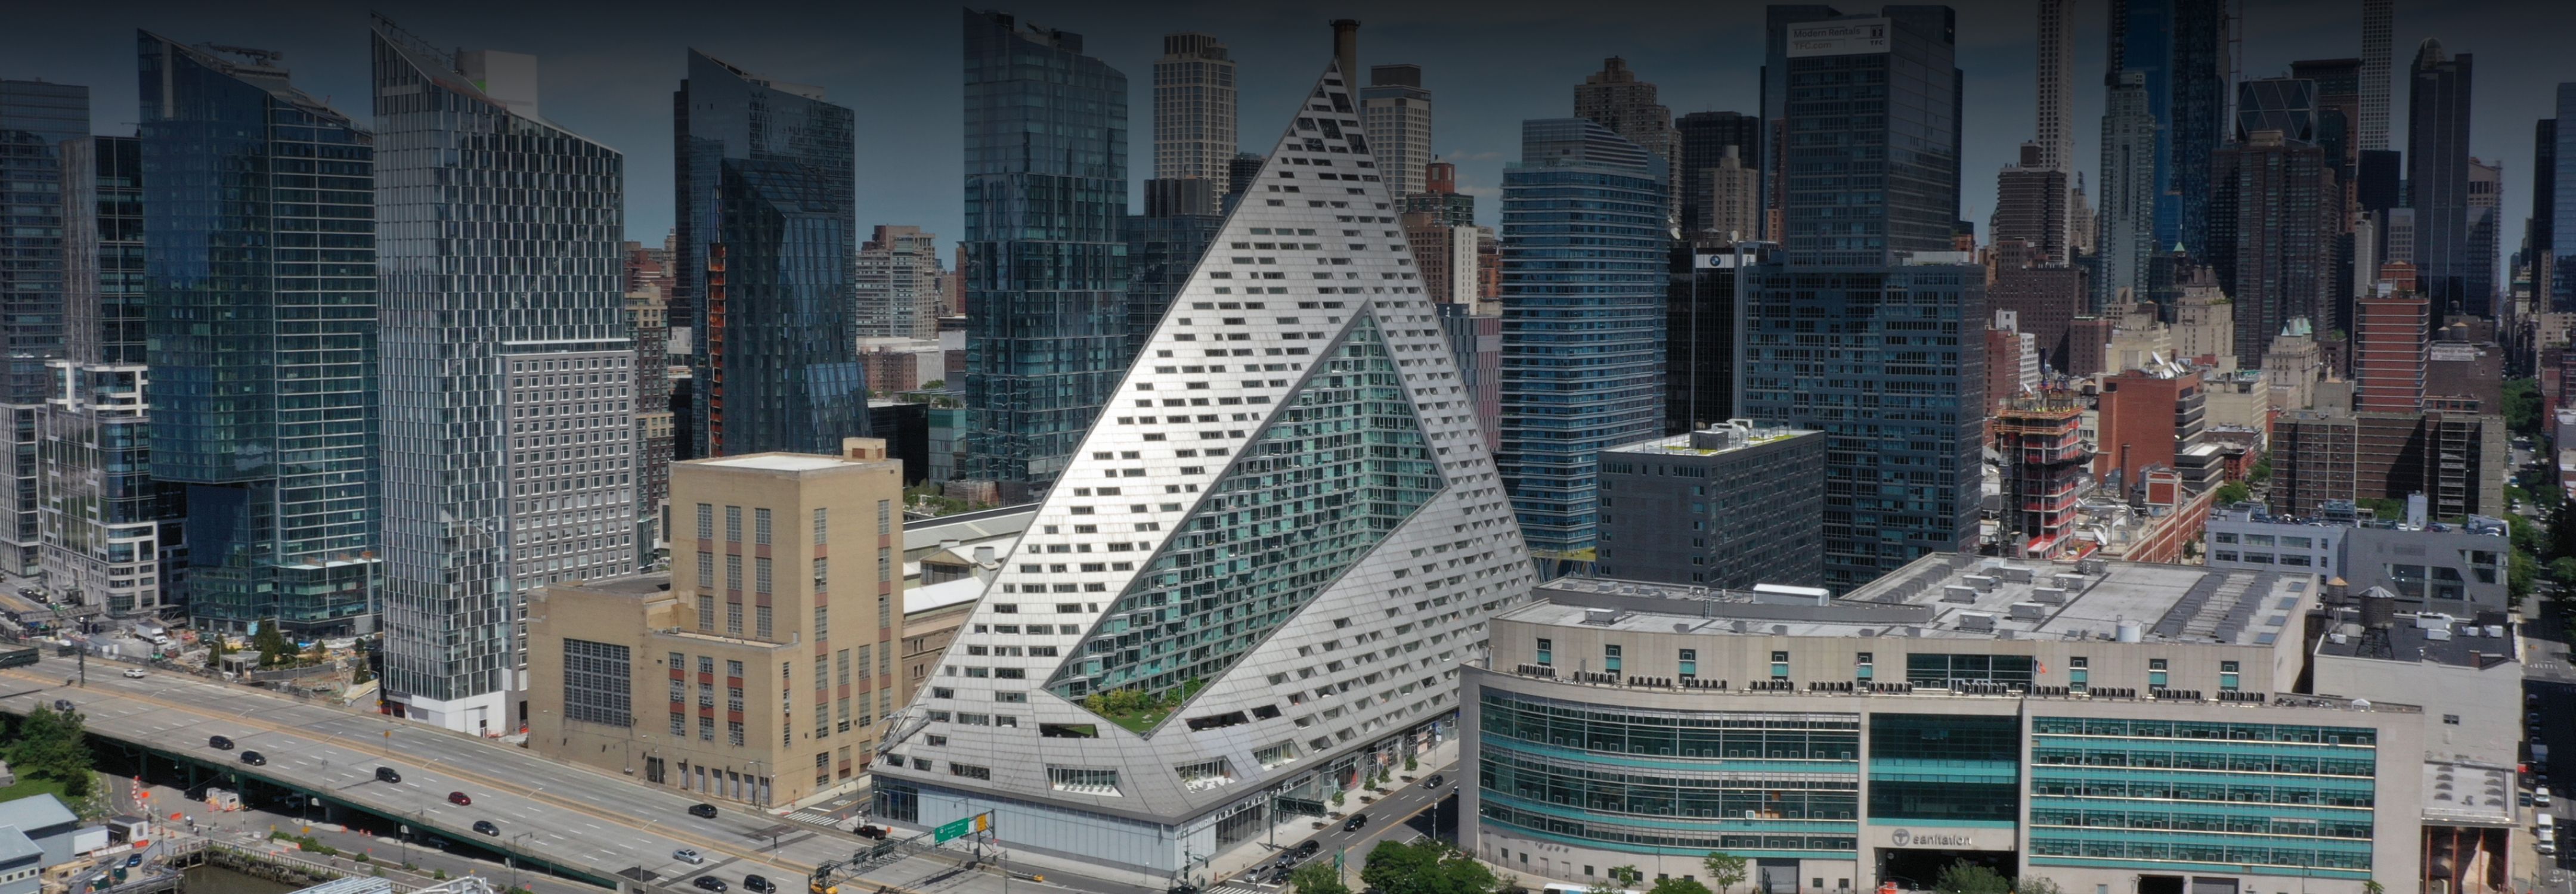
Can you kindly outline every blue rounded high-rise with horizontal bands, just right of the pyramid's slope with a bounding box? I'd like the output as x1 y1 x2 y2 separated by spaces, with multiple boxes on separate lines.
1497 119 1669 561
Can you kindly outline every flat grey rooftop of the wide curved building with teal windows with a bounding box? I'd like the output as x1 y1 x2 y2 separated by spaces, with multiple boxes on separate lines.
1504 554 2318 647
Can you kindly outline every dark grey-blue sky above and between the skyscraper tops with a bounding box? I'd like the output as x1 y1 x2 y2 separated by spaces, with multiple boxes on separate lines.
0 0 2576 268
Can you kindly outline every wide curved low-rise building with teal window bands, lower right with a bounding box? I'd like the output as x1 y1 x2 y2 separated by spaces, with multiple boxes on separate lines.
1458 554 2522 894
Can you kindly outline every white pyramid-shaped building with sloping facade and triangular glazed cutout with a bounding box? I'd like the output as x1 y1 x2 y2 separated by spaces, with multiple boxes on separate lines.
873 61 1532 879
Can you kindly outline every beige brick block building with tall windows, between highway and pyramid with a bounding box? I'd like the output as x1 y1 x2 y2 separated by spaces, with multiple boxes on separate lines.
528 438 904 806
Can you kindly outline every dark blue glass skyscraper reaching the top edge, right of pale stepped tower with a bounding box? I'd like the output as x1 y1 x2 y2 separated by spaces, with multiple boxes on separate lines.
2156 0 2236 255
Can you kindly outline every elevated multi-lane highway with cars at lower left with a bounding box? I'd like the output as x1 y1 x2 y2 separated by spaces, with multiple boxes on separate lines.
0 657 834 892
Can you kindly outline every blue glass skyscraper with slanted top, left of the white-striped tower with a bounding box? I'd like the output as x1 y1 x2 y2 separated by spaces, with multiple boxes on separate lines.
137 31 379 637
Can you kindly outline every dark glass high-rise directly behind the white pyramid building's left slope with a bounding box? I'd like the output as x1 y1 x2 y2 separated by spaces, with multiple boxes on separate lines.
958 10 1123 500
